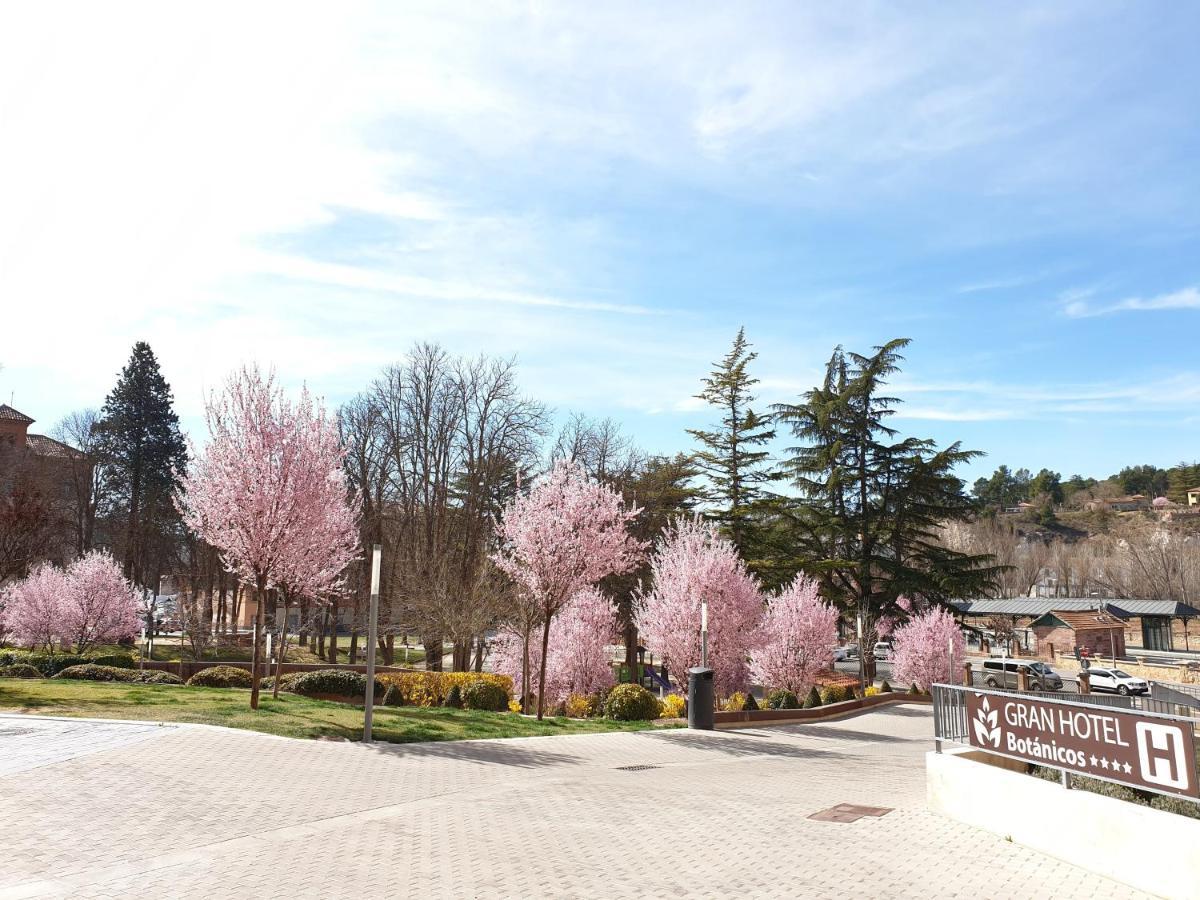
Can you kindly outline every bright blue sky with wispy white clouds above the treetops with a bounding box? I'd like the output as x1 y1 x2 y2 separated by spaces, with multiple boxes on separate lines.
0 2 1200 487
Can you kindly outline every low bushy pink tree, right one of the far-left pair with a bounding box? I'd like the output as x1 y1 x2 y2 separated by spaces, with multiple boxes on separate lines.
59 551 142 653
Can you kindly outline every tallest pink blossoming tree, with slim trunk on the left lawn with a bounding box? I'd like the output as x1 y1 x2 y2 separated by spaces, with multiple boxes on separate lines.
176 366 357 709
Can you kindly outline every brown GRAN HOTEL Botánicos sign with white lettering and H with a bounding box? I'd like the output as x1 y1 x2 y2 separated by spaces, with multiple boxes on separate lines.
966 691 1200 797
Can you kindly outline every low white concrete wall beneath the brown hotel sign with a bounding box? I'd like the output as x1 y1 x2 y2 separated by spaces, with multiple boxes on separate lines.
925 750 1200 898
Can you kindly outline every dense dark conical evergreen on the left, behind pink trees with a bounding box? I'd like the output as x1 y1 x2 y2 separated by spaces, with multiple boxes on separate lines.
97 341 187 589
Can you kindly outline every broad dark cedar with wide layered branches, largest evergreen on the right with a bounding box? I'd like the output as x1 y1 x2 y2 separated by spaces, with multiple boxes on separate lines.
775 338 997 681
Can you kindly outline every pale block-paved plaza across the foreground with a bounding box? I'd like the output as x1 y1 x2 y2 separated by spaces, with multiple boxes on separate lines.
0 704 1139 900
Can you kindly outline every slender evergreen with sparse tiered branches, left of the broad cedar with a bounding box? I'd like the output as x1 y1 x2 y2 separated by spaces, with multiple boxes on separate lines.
688 328 775 558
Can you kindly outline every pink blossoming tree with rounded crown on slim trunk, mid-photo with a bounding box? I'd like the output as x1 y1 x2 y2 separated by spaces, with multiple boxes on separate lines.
493 461 644 719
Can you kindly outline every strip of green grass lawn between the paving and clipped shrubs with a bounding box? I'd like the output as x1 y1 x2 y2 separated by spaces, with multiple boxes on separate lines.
0 678 654 744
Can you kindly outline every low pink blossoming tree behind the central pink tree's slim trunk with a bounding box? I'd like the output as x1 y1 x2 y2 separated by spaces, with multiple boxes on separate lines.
492 588 617 704
